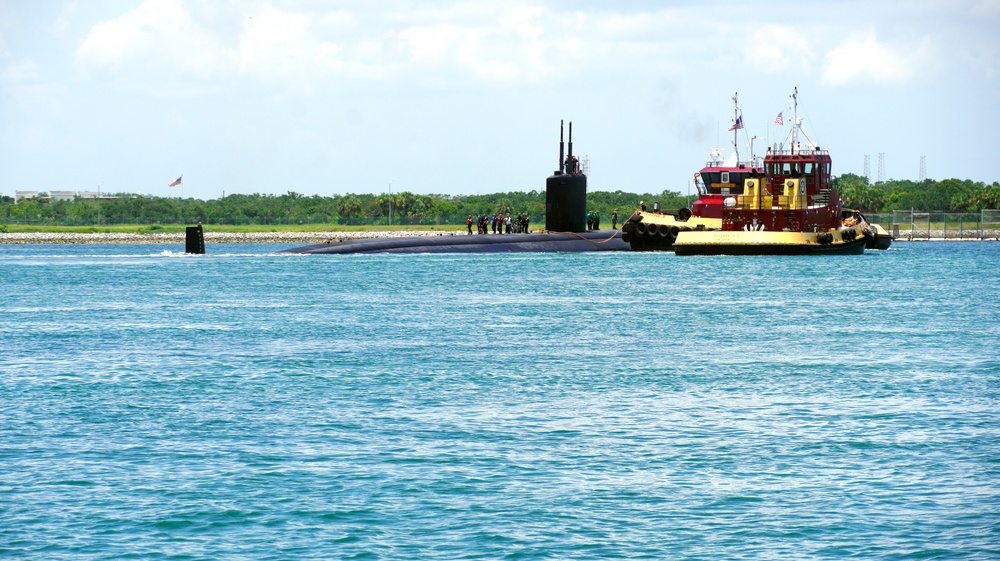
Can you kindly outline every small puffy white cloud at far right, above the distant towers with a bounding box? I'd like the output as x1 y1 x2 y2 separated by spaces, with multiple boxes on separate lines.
822 29 922 86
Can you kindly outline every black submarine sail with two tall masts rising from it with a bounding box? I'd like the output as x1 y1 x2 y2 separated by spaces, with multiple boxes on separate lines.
545 121 587 232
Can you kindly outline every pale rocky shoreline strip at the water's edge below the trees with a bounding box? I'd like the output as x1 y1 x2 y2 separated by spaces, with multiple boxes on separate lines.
0 230 1000 245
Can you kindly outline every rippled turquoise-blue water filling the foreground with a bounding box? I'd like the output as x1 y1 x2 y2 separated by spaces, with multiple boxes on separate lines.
0 243 1000 560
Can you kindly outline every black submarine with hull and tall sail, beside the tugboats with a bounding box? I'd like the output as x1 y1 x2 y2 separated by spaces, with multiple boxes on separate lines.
279 121 632 255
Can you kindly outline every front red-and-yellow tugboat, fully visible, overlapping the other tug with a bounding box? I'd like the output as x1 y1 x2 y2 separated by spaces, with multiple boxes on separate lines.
673 88 877 255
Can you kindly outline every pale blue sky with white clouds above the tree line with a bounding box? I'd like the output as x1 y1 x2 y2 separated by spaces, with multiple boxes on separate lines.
0 0 1000 199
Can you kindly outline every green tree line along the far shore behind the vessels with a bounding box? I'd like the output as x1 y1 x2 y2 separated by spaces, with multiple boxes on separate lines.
0 173 1000 226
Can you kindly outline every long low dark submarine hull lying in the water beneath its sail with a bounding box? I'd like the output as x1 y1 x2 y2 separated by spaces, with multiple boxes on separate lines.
280 230 631 255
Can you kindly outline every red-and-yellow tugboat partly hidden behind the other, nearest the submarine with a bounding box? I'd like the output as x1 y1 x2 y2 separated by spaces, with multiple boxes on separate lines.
622 95 763 251
